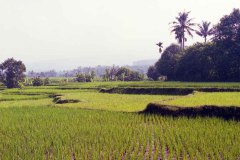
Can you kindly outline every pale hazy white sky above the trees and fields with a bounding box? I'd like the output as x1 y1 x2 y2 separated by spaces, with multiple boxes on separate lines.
0 0 240 70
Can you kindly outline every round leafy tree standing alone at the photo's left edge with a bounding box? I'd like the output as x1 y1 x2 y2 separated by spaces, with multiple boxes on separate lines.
0 58 26 88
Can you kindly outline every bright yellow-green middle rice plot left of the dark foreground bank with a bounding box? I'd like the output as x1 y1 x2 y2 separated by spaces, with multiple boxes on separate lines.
58 91 173 112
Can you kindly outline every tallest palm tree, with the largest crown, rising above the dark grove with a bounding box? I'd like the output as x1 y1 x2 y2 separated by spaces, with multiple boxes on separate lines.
171 12 195 49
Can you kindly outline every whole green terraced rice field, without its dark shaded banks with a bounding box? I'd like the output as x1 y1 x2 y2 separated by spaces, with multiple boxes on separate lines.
0 82 240 160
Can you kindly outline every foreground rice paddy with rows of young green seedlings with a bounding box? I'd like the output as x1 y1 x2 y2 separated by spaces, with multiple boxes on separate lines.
0 107 240 159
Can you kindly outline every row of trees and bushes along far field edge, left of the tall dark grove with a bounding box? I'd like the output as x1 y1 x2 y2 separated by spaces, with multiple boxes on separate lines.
0 58 144 88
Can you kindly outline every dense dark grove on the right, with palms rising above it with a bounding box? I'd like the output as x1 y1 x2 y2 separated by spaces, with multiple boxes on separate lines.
147 9 240 81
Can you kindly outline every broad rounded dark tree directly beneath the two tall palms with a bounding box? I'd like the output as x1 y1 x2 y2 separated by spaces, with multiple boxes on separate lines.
175 43 219 82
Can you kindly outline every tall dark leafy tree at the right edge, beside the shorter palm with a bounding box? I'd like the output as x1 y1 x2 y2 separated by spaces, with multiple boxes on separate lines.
213 9 240 81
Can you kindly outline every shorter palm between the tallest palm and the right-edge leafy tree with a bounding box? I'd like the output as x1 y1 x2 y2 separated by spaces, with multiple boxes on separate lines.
196 21 214 43
